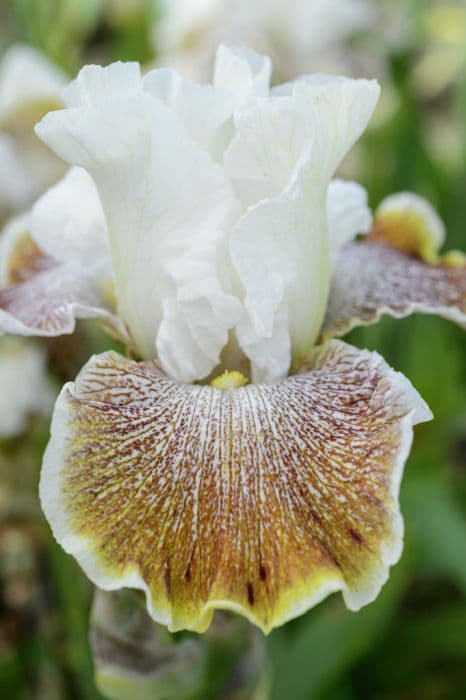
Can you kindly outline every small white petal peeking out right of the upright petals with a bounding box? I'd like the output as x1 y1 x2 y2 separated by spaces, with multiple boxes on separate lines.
327 180 372 261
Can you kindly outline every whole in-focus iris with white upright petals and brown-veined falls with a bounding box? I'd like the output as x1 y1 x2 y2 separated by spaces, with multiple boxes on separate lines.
0 46 466 632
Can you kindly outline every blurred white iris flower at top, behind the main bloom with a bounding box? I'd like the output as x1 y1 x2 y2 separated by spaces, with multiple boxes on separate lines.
153 0 412 91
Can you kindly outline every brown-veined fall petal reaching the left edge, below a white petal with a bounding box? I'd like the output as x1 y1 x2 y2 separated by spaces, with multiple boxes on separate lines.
0 229 127 340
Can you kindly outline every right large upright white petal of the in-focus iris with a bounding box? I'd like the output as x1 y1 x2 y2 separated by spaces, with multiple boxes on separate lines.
226 76 378 381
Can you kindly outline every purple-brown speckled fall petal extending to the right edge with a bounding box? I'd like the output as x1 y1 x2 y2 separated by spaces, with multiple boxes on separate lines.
322 241 466 339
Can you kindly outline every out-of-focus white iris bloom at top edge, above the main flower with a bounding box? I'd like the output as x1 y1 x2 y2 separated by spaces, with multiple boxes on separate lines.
154 0 374 76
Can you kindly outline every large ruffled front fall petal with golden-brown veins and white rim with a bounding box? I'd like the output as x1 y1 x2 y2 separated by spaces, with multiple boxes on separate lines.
40 341 431 632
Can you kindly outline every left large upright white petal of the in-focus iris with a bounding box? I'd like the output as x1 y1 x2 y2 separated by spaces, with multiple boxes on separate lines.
38 67 240 380
